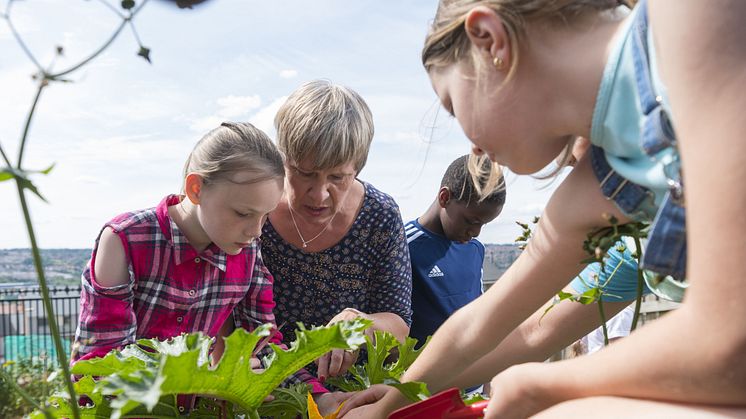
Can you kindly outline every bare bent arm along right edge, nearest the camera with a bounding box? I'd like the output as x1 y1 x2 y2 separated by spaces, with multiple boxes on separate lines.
480 0 746 417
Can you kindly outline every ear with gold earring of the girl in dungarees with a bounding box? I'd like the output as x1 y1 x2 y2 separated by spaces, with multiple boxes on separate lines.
464 6 510 70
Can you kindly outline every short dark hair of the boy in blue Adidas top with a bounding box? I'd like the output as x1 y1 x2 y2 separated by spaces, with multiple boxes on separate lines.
440 154 506 205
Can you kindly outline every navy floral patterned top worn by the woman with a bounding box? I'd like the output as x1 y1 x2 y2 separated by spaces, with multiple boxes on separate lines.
262 182 412 342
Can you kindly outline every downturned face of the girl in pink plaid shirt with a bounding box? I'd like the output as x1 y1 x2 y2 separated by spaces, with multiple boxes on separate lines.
197 172 283 255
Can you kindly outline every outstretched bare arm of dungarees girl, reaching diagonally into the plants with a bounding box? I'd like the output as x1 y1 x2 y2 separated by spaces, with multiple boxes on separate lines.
342 158 626 417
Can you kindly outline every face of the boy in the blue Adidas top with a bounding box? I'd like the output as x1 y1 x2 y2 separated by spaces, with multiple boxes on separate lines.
440 189 503 243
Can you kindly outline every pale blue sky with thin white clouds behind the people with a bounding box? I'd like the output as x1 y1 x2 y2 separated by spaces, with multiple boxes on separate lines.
0 0 558 248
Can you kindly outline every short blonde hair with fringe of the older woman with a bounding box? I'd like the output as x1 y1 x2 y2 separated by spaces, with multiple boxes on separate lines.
275 80 373 172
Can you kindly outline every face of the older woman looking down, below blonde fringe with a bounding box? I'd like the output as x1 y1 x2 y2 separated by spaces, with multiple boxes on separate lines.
285 158 357 225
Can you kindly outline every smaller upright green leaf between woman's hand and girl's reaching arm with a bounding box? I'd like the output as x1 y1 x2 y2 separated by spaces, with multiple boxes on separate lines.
327 330 430 401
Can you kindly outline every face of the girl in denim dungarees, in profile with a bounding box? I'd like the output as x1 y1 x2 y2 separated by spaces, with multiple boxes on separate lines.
430 63 570 174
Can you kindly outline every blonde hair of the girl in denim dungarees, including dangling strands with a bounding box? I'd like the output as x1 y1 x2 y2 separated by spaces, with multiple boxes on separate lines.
422 0 636 197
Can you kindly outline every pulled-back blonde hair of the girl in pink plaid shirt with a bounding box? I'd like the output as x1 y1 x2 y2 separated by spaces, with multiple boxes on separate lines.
182 122 285 192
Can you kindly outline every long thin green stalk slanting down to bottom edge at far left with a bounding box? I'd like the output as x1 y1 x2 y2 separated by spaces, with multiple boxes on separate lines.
16 185 80 419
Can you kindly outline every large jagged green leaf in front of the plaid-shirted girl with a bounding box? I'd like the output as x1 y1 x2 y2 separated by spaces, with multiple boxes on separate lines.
31 319 370 418
